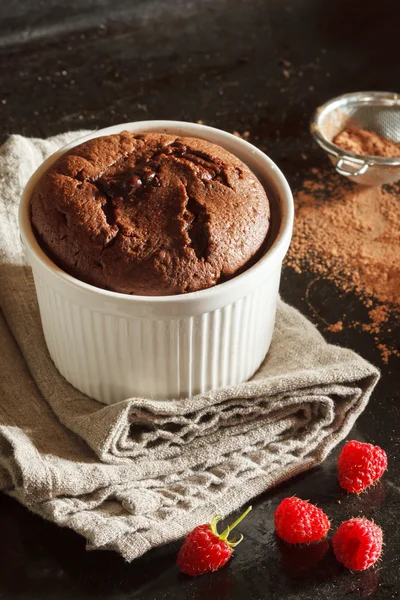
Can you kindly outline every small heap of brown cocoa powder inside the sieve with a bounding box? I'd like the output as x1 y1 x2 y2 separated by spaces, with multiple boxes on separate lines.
333 128 400 158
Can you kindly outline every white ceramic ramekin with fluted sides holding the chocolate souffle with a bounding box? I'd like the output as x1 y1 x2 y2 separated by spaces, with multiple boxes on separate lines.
19 121 293 404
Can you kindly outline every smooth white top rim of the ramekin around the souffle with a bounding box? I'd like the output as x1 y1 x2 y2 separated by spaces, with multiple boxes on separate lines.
18 119 294 305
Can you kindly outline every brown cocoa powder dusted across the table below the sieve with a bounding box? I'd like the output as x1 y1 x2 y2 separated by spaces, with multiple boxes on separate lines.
286 168 400 362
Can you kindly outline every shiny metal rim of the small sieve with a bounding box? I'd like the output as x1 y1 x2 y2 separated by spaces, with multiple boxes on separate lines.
310 92 400 167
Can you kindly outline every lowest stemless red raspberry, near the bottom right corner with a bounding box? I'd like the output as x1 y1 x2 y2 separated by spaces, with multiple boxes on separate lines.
332 517 383 571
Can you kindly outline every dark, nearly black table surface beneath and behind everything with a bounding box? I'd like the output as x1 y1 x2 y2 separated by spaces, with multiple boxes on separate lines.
0 0 400 600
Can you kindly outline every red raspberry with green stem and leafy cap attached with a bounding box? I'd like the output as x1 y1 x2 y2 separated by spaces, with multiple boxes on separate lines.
177 506 251 577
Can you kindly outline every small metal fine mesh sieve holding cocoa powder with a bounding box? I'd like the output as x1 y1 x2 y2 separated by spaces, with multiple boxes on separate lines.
311 92 400 185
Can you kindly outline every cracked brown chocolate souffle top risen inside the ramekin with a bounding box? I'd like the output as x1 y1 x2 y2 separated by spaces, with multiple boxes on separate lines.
31 132 270 296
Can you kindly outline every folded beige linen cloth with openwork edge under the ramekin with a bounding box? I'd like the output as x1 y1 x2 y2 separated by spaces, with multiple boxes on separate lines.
0 132 379 560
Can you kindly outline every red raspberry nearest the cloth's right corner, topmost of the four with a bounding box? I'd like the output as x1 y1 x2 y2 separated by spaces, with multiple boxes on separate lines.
338 440 387 494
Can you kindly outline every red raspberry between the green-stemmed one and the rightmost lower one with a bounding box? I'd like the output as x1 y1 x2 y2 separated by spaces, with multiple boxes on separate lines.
274 497 331 544
